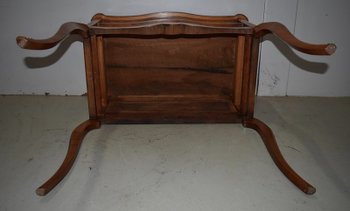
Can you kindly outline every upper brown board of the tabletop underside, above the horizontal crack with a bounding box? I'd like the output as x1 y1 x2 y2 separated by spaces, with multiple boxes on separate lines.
105 37 235 71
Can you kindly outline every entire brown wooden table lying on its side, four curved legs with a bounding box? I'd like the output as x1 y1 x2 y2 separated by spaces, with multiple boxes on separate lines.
17 12 336 195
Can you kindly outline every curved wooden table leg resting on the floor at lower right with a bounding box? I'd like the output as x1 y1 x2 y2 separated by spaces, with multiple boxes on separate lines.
243 118 316 195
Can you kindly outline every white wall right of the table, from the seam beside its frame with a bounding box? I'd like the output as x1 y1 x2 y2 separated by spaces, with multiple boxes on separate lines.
258 0 350 96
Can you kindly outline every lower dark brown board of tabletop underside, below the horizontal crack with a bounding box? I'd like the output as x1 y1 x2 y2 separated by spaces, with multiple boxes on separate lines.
106 68 232 97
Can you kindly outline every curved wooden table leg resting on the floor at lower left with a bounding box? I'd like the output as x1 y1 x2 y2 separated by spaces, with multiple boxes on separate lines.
35 120 101 196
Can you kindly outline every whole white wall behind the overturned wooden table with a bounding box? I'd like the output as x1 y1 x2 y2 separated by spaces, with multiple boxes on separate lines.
0 0 350 96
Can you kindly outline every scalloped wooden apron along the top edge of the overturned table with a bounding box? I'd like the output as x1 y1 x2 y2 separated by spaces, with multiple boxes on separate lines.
91 12 252 36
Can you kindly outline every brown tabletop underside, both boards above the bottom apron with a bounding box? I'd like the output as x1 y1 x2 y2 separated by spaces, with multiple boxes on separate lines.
104 37 236 96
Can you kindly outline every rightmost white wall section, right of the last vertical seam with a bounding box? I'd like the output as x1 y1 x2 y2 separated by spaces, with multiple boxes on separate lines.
287 0 350 96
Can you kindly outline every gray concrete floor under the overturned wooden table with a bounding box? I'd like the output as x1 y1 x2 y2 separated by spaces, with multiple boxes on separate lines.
0 96 350 211
